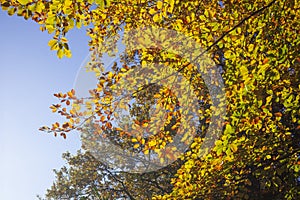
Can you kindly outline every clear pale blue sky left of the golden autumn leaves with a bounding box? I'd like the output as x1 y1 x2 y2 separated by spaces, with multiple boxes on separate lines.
0 11 89 200
